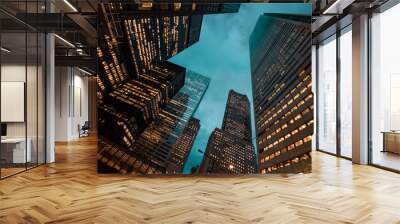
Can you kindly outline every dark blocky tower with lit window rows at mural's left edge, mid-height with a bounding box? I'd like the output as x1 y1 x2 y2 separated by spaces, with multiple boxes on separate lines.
98 62 186 147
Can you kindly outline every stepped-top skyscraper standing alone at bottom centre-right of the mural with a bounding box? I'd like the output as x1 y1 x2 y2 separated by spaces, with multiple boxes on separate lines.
200 90 257 174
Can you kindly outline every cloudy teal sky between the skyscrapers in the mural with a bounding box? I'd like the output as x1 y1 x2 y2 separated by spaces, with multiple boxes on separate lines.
170 3 311 173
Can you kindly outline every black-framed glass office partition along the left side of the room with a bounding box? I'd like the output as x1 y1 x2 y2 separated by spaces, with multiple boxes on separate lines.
0 1 46 178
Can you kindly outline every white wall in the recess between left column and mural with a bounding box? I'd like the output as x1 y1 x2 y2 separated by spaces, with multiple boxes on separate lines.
55 67 89 141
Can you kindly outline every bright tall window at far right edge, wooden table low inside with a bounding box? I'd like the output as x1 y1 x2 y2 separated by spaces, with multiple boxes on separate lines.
370 4 400 171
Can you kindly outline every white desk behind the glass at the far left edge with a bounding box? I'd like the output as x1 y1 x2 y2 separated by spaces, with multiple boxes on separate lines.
1 138 32 163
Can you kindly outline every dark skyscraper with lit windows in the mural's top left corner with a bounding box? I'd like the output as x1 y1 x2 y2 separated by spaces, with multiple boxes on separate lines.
100 2 240 78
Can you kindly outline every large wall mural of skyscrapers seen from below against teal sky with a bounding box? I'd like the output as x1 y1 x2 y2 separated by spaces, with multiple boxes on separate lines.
97 3 314 175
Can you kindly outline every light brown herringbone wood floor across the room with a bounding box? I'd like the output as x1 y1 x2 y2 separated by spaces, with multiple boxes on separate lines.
0 138 400 224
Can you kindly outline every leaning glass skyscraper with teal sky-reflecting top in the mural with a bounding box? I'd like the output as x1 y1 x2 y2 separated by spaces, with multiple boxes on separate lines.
133 71 210 173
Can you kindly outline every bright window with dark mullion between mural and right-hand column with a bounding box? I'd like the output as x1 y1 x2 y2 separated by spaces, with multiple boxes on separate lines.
316 25 353 159
